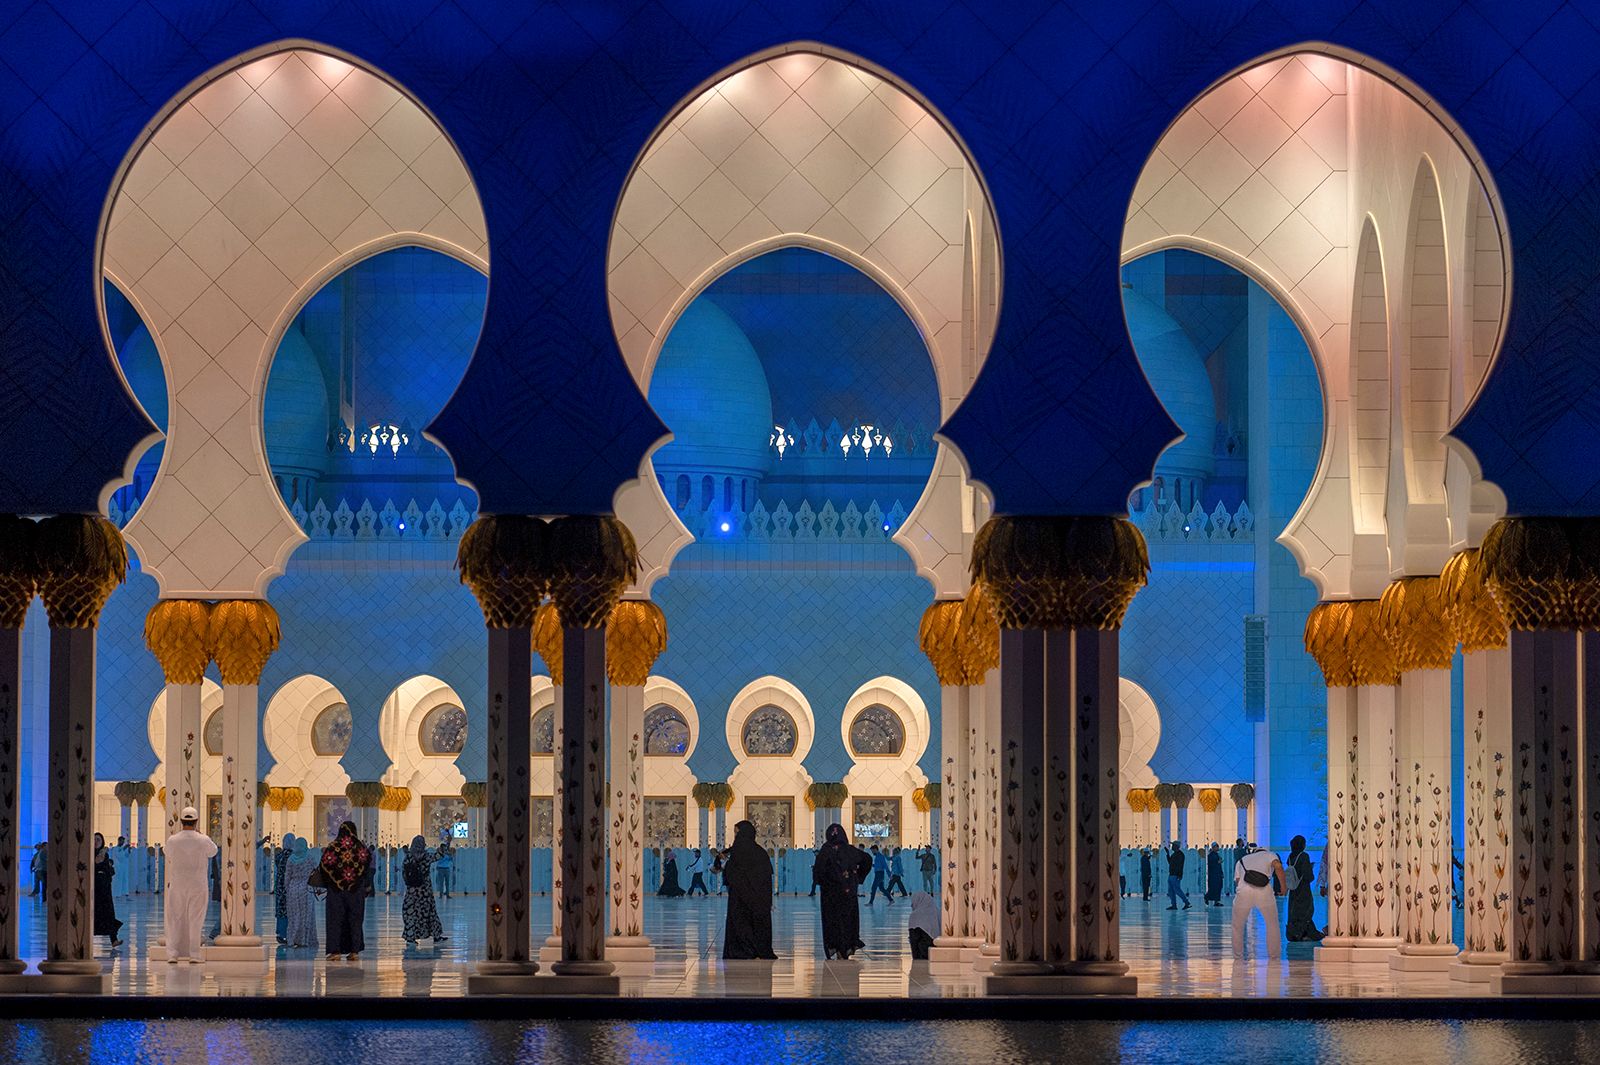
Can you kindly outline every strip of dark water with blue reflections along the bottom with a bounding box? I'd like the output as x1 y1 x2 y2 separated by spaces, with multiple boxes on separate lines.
0 1003 1600 1065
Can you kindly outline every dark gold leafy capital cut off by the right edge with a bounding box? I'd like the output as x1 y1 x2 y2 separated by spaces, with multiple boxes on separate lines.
1478 517 1600 632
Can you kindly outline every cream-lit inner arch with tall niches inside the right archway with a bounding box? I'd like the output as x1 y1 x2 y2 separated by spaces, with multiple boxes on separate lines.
1123 43 1510 598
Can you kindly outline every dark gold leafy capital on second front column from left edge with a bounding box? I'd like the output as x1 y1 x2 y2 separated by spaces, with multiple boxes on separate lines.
34 513 128 628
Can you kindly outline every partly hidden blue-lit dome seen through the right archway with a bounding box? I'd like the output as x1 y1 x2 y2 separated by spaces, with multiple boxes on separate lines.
1122 289 1216 481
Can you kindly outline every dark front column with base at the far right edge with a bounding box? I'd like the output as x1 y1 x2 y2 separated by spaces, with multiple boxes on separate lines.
1490 628 1600 995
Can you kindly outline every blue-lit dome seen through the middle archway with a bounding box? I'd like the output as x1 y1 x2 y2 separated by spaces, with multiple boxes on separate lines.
650 297 773 475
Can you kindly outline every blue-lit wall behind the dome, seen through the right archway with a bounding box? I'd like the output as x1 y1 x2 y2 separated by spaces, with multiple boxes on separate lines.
1122 251 1326 843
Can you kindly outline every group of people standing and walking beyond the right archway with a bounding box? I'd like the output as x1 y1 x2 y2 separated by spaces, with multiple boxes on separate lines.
1122 836 1326 958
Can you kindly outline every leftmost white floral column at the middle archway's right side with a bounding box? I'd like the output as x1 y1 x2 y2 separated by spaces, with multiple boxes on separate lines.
934 684 981 967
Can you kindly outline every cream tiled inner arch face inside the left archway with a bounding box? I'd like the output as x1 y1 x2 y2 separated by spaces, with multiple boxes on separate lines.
98 42 488 598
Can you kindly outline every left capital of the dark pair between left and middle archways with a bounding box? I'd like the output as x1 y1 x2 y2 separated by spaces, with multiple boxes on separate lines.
456 513 550 628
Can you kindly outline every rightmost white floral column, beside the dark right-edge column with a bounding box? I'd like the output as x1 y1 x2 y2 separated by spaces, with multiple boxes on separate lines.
1450 648 1514 983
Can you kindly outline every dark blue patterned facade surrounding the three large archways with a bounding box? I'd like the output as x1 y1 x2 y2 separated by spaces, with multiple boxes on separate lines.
0 0 1600 513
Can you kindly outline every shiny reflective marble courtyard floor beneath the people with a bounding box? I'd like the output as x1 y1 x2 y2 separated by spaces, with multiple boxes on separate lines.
3 894 1510 999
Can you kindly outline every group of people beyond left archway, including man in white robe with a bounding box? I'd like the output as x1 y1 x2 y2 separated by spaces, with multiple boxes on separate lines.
154 806 453 964
